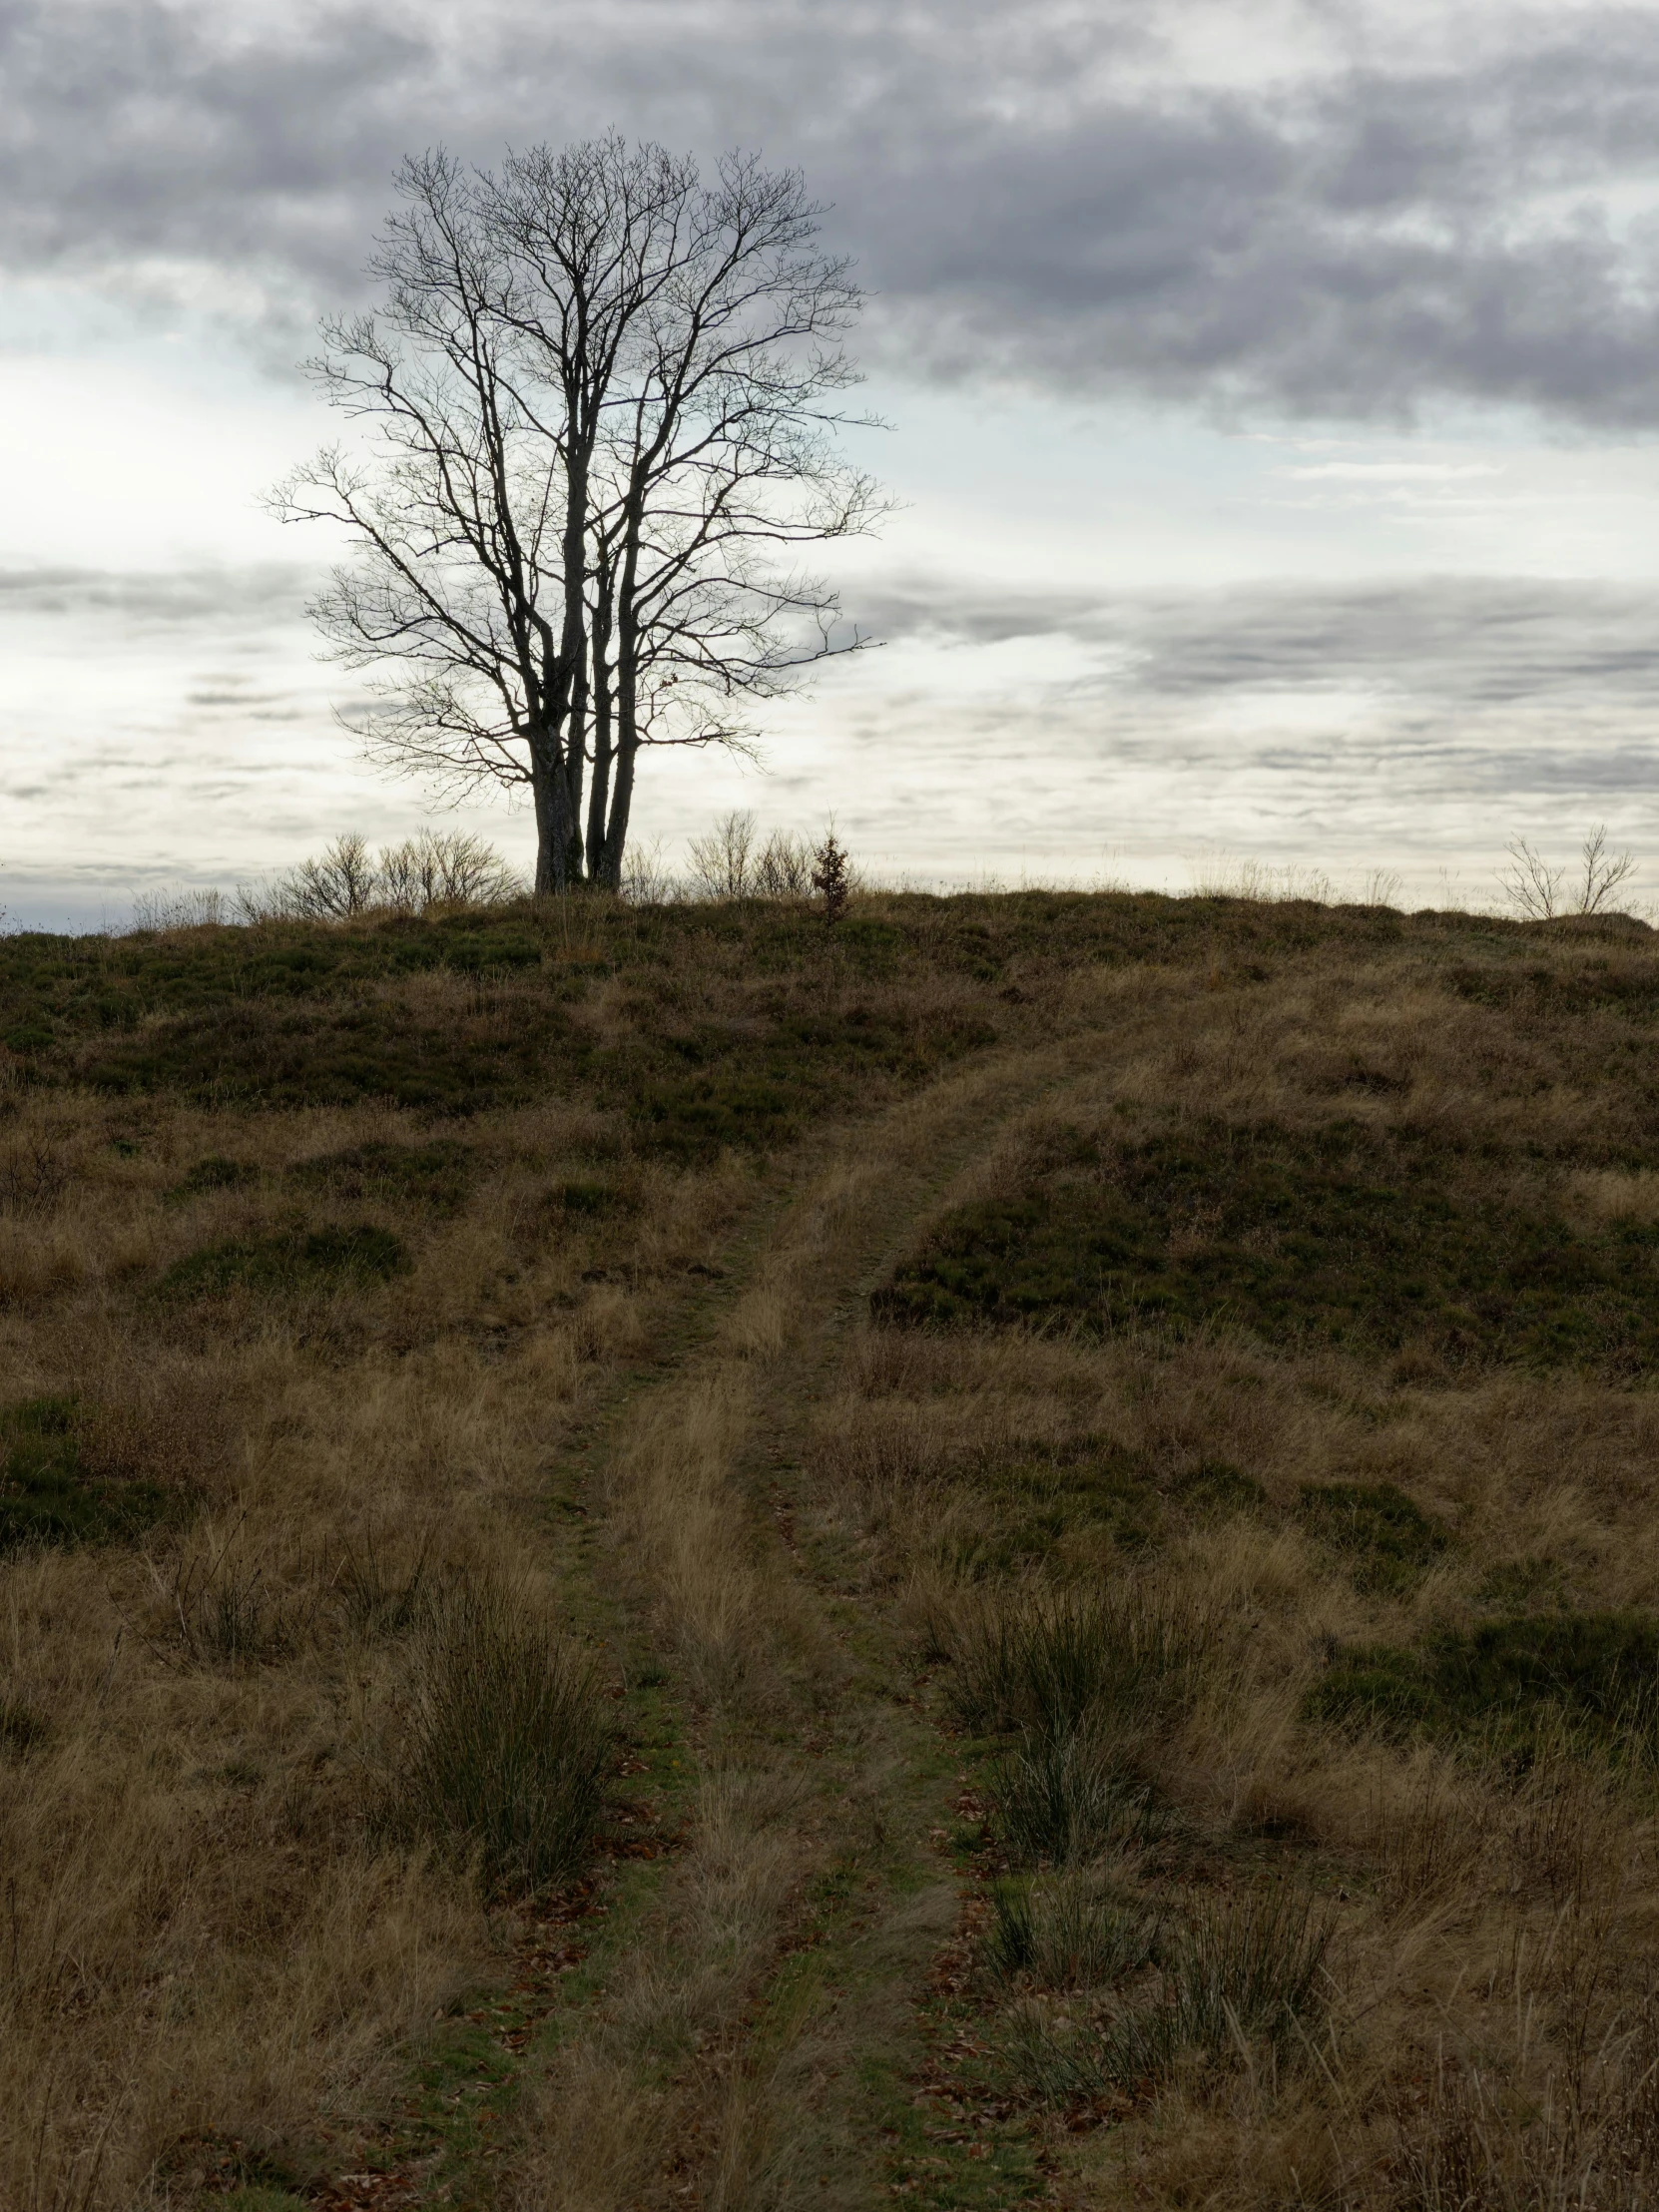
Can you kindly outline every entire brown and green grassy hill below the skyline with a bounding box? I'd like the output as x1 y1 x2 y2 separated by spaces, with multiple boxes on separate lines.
0 893 1659 2212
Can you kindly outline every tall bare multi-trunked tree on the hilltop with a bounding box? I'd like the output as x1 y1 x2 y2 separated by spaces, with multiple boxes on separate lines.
273 135 880 891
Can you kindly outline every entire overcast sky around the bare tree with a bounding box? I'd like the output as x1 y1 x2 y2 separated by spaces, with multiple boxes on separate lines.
0 0 1659 924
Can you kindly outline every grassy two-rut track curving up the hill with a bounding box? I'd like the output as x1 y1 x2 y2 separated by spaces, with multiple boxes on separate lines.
504 1037 1119 2212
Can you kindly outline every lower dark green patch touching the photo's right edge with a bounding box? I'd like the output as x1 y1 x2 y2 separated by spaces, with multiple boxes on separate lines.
1308 1612 1659 1757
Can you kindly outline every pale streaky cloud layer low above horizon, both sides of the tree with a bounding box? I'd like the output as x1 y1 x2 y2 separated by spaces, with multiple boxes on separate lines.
0 569 1659 918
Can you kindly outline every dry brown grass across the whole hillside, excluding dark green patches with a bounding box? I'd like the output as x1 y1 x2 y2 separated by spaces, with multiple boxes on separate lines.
0 902 1659 2212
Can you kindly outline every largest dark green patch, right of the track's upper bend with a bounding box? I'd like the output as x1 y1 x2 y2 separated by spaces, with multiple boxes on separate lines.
871 1119 1659 1374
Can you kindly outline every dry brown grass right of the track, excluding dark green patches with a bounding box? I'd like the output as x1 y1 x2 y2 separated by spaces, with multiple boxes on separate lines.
783 928 1659 2212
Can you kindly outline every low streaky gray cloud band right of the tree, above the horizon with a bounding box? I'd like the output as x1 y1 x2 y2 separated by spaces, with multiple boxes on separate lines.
844 575 1659 860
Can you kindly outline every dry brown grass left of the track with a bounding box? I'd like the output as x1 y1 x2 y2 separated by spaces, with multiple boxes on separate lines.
0 1074 748 2208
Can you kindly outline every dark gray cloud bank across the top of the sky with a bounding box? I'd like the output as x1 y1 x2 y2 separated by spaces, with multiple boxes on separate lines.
0 0 1659 431
